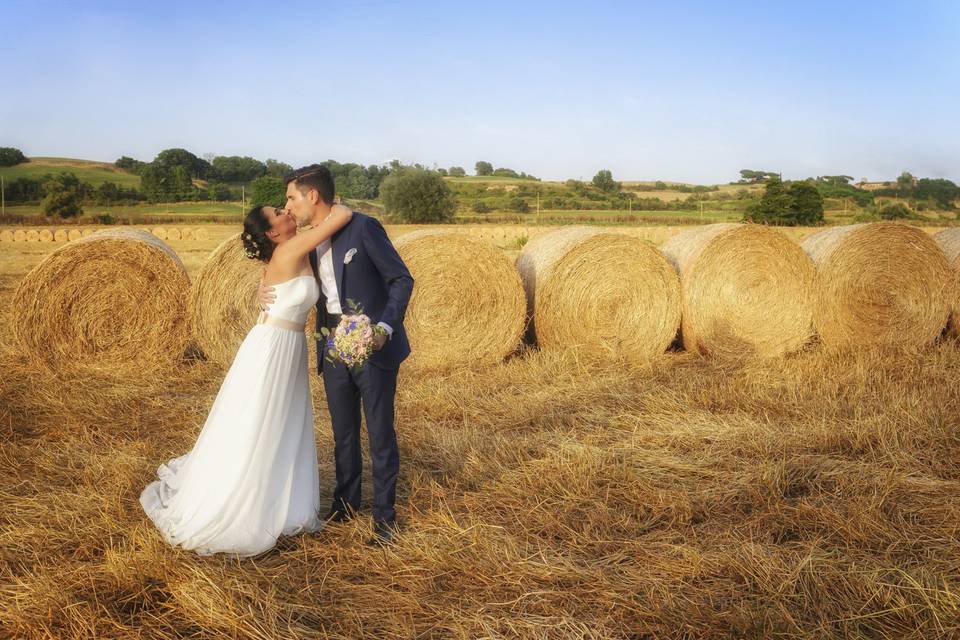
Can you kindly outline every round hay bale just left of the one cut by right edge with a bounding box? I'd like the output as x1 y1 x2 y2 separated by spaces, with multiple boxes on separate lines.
802 222 952 350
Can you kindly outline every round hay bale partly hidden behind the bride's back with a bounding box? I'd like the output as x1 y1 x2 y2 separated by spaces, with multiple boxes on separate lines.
187 233 264 365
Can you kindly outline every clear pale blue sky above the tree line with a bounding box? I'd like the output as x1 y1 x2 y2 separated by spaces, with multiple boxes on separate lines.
0 0 960 182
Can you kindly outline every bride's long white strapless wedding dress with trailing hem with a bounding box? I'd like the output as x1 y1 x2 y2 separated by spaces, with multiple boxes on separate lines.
140 276 321 556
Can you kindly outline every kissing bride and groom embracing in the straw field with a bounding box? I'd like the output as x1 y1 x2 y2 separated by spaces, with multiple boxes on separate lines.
140 164 413 556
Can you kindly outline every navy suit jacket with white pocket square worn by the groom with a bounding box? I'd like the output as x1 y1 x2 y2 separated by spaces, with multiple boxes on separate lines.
310 211 413 373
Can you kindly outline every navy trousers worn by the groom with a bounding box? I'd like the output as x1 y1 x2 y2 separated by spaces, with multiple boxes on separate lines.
323 361 400 521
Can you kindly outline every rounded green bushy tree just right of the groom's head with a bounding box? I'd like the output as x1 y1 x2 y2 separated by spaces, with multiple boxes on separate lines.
380 168 457 223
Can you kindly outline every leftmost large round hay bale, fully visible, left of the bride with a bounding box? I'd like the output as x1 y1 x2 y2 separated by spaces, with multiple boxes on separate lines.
10 230 190 374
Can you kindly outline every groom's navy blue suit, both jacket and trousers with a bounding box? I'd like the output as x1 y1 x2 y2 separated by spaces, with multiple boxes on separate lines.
310 212 413 521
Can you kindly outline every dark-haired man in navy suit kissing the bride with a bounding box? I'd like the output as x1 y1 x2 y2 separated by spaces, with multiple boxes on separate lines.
259 164 413 544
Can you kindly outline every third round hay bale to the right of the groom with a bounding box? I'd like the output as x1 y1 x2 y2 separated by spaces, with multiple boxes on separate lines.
660 223 816 357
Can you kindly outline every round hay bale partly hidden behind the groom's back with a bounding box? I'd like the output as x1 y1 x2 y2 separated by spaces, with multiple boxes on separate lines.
395 229 526 367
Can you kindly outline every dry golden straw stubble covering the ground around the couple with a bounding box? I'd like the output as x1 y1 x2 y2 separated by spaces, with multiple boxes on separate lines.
0 226 960 638
